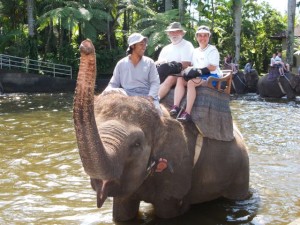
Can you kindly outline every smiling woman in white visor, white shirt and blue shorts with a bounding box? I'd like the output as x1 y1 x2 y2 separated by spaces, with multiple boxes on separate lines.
170 26 222 121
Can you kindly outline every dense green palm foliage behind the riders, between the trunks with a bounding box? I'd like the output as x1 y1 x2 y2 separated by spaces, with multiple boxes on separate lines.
0 0 300 74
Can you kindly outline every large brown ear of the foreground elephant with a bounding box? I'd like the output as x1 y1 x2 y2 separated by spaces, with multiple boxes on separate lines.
146 118 193 199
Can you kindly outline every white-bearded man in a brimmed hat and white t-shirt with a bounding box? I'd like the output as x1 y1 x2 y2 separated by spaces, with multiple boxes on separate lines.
156 22 194 98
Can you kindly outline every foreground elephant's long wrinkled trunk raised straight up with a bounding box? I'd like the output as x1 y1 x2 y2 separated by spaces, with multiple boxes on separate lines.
73 40 114 180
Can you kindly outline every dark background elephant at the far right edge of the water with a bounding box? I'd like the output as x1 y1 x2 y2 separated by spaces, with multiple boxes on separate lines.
258 67 300 99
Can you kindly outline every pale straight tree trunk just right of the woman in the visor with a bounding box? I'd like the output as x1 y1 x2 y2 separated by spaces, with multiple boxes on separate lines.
233 0 243 63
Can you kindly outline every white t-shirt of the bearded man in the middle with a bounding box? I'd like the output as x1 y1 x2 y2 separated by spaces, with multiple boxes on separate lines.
157 39 194 62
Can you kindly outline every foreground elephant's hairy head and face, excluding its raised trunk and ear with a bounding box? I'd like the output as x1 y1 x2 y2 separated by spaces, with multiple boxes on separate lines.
87 94 163 207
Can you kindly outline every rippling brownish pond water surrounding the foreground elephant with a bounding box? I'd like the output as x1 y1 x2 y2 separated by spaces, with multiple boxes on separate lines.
0 94 300 225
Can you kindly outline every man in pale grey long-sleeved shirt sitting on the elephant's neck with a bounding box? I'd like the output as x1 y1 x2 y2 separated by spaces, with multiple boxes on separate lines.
103 33 160 111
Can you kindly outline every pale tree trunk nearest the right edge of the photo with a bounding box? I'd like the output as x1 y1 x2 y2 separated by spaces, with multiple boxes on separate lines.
286 0 296 68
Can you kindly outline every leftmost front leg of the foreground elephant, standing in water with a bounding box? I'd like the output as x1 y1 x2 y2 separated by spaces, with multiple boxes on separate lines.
113 197 140 221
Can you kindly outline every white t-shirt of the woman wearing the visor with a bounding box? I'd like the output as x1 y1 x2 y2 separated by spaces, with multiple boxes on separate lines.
192 45 223 77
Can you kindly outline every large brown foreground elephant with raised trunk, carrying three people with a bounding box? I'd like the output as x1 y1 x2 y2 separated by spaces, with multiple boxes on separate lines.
73 39 249 221
